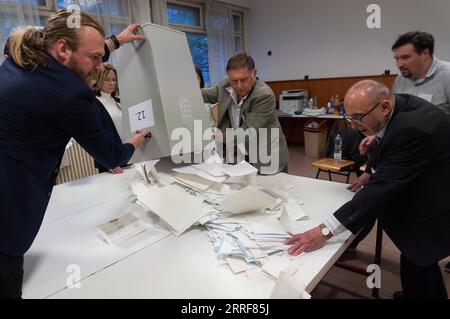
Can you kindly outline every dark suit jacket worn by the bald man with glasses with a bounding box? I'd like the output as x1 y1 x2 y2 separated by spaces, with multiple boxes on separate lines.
334 94 450 266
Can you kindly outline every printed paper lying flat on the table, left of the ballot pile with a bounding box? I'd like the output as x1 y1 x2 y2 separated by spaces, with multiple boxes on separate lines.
97 212 147 245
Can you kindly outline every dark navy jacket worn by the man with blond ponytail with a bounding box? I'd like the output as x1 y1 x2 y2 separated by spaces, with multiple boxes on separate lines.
0 58 134 256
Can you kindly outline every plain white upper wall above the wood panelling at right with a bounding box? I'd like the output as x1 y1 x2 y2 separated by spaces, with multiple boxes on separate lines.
246 0 450 81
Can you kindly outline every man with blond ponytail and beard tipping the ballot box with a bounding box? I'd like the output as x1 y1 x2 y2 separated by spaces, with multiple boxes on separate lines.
0 11 148 298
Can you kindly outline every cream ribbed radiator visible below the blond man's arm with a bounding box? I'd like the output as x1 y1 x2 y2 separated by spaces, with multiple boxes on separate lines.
55 140 98 184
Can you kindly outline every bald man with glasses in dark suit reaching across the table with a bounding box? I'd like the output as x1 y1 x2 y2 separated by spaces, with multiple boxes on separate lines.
285 80 450 299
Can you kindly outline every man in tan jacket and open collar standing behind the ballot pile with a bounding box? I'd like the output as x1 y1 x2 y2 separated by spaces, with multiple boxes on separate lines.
202 52 289 174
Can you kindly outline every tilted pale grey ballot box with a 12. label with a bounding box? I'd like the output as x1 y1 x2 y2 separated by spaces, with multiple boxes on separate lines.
117 24 210 163
